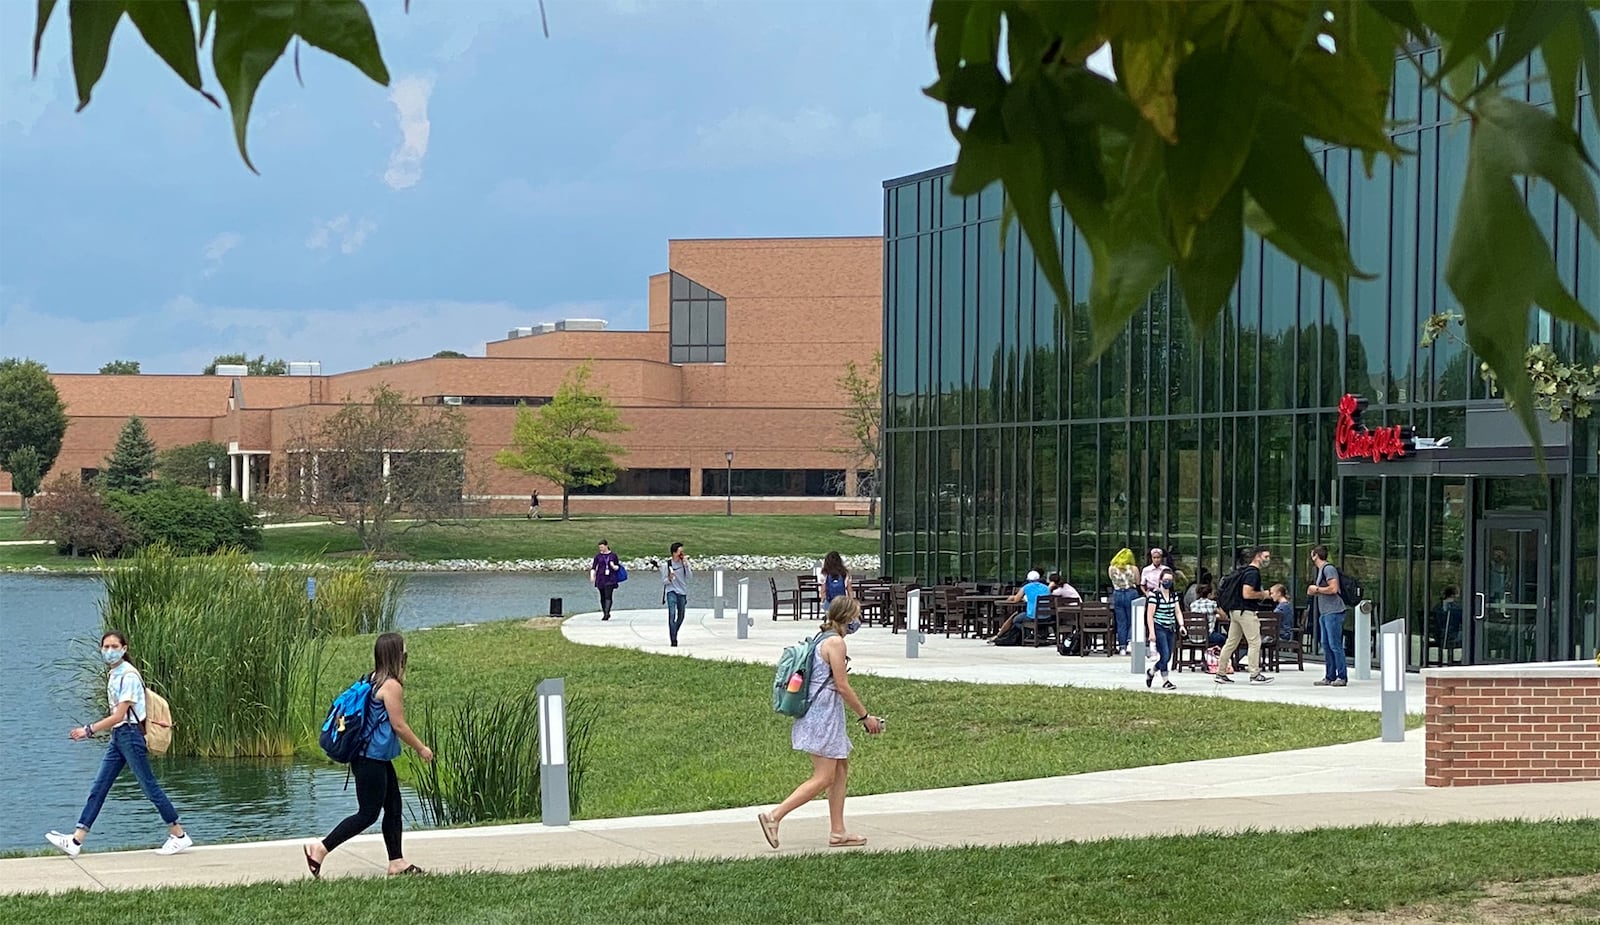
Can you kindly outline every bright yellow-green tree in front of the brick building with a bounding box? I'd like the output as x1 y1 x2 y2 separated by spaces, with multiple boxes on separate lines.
494 363 630 520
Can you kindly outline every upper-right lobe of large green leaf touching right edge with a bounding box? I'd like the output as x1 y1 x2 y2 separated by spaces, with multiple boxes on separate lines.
1472 93 1600 234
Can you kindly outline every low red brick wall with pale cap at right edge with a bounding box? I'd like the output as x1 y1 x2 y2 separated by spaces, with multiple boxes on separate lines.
1422 661 1600 787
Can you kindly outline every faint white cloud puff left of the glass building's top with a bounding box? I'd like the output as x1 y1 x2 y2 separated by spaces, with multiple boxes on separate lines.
690 106 888 166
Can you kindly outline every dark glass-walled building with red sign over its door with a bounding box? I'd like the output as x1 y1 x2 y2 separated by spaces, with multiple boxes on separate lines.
883 51 1600 667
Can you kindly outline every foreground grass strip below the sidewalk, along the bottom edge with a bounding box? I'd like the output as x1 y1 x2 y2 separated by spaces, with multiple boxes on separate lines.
0 819 1600 925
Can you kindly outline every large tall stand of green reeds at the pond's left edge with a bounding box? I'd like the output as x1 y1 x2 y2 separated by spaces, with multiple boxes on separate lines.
94 547 398 757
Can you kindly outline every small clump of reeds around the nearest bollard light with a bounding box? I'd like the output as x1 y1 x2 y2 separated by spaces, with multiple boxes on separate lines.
406 688 600 826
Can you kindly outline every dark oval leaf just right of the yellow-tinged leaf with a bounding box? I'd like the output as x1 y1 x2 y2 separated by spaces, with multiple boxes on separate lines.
1166 50 1261 232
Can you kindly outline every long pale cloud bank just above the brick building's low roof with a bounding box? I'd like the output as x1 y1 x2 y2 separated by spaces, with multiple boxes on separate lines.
0 296 645 373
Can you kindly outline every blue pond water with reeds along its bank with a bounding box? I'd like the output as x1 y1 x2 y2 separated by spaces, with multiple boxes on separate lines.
0 573 794 851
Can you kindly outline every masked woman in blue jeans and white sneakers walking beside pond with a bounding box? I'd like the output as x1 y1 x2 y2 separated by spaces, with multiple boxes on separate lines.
45 631 194 858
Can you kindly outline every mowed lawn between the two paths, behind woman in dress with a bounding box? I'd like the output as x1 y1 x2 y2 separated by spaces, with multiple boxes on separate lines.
307 621 1401 818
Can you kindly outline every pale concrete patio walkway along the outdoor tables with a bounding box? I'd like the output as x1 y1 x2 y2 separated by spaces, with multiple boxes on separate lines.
562 608 1422 713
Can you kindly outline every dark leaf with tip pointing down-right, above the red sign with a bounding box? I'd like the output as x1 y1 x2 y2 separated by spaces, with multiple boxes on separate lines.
1243 107 1373 312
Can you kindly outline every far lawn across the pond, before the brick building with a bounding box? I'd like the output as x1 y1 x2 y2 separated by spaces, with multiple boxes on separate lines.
0 514 878 568
